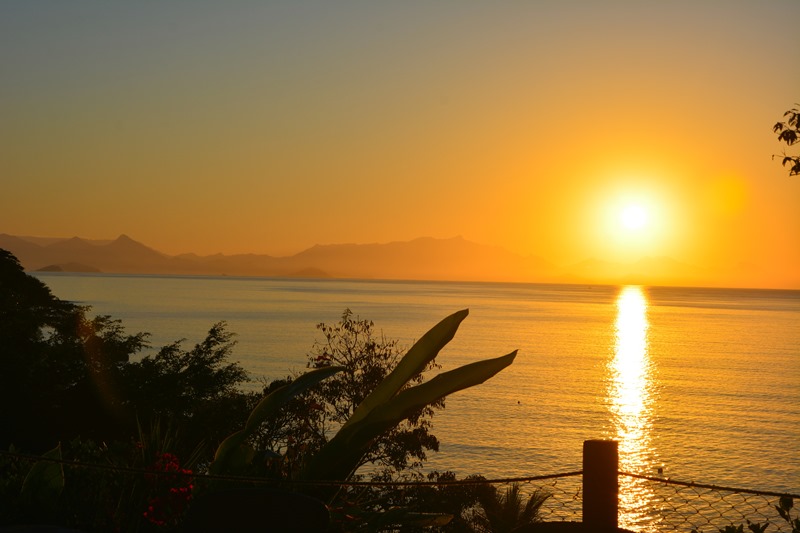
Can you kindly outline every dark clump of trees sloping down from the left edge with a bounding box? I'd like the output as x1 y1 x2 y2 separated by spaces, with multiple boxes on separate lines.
0 249 255 453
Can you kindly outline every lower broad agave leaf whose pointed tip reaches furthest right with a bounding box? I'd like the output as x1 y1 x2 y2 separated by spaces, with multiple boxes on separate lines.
302 350 517 480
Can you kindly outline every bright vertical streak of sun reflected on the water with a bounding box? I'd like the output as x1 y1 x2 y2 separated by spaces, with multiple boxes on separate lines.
608 286 657 530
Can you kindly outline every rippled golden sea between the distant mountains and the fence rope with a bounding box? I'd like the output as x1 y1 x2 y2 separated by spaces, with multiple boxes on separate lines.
36 273 800 528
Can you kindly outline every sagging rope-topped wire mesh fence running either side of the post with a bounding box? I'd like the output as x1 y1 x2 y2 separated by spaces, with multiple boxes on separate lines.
0 451 800 533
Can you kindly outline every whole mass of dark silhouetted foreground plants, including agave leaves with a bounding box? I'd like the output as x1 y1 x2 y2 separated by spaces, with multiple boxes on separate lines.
0 250 547 532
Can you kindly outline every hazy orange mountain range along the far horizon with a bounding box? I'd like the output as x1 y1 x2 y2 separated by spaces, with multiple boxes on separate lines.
0 233 752 286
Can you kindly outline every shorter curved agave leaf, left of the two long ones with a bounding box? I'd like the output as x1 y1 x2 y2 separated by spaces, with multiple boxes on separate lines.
209 366 344 474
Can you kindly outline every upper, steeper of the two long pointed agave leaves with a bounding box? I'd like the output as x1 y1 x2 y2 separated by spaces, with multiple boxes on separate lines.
342 309 469 429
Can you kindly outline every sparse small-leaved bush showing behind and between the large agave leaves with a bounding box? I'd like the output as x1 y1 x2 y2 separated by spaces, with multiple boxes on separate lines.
256 309 444 481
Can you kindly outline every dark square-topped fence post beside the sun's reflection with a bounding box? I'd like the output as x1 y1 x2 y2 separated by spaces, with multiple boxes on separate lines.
583 440 619 531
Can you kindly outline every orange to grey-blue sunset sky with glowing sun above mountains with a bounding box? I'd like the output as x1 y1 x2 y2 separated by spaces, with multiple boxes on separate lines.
0 0 800 286
